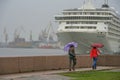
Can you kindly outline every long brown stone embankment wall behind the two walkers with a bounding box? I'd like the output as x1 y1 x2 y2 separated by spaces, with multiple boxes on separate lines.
0 55 120 74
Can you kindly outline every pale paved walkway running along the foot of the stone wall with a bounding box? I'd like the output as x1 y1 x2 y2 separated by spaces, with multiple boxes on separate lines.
0 67 116 80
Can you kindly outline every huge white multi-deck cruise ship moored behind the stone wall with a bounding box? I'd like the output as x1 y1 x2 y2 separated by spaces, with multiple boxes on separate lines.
55 0 120 54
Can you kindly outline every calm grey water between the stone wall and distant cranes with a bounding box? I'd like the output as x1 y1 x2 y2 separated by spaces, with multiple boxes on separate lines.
0 48 67 57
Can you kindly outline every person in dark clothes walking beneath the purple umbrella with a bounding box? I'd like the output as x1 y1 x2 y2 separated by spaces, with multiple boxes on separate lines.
68 45 76 71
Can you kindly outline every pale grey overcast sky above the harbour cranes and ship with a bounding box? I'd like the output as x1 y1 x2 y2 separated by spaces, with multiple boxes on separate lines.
0 0 120 42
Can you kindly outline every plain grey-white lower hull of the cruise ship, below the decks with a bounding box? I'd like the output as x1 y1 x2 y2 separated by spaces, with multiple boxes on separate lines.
57 32 120 54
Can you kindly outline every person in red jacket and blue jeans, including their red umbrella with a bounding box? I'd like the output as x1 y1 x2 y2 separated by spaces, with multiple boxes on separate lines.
90 43 103 69
